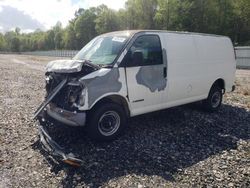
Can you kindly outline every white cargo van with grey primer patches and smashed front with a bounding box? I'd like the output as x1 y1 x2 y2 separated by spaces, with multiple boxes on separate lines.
35 30 236 166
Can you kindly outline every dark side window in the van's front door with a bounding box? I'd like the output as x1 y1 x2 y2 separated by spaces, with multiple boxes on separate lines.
125 35 163 67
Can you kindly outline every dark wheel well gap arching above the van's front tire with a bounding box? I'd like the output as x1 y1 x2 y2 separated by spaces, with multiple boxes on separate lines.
92 95 130 117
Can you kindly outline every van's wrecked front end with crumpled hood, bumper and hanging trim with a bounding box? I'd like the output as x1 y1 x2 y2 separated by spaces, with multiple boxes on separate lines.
34 60 99 166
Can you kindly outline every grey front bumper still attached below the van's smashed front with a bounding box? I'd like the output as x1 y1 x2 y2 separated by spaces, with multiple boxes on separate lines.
46 103 86 126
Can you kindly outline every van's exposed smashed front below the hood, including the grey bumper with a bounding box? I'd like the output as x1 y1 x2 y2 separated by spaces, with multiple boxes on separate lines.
45 73 86 126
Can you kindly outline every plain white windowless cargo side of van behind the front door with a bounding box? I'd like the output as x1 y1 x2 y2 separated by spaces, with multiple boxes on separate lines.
166 33 235 106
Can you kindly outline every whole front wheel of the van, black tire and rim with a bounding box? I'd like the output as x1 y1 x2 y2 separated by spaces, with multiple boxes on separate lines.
87 103 126 141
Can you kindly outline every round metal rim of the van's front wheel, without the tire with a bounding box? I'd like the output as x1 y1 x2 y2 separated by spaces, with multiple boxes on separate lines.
98 111 120 136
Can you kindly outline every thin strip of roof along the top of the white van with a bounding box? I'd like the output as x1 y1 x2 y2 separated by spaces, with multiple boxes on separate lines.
103 30 225 37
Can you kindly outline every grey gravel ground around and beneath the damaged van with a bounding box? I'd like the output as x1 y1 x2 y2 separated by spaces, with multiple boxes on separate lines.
0 55 250 188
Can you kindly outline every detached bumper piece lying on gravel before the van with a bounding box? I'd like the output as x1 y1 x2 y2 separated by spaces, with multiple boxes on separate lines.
38 119 83 167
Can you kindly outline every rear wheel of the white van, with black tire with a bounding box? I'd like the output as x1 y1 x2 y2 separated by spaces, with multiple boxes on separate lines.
202 84 223 112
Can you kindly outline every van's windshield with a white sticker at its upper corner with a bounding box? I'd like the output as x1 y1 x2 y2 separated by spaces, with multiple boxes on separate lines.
73 36 128 65
